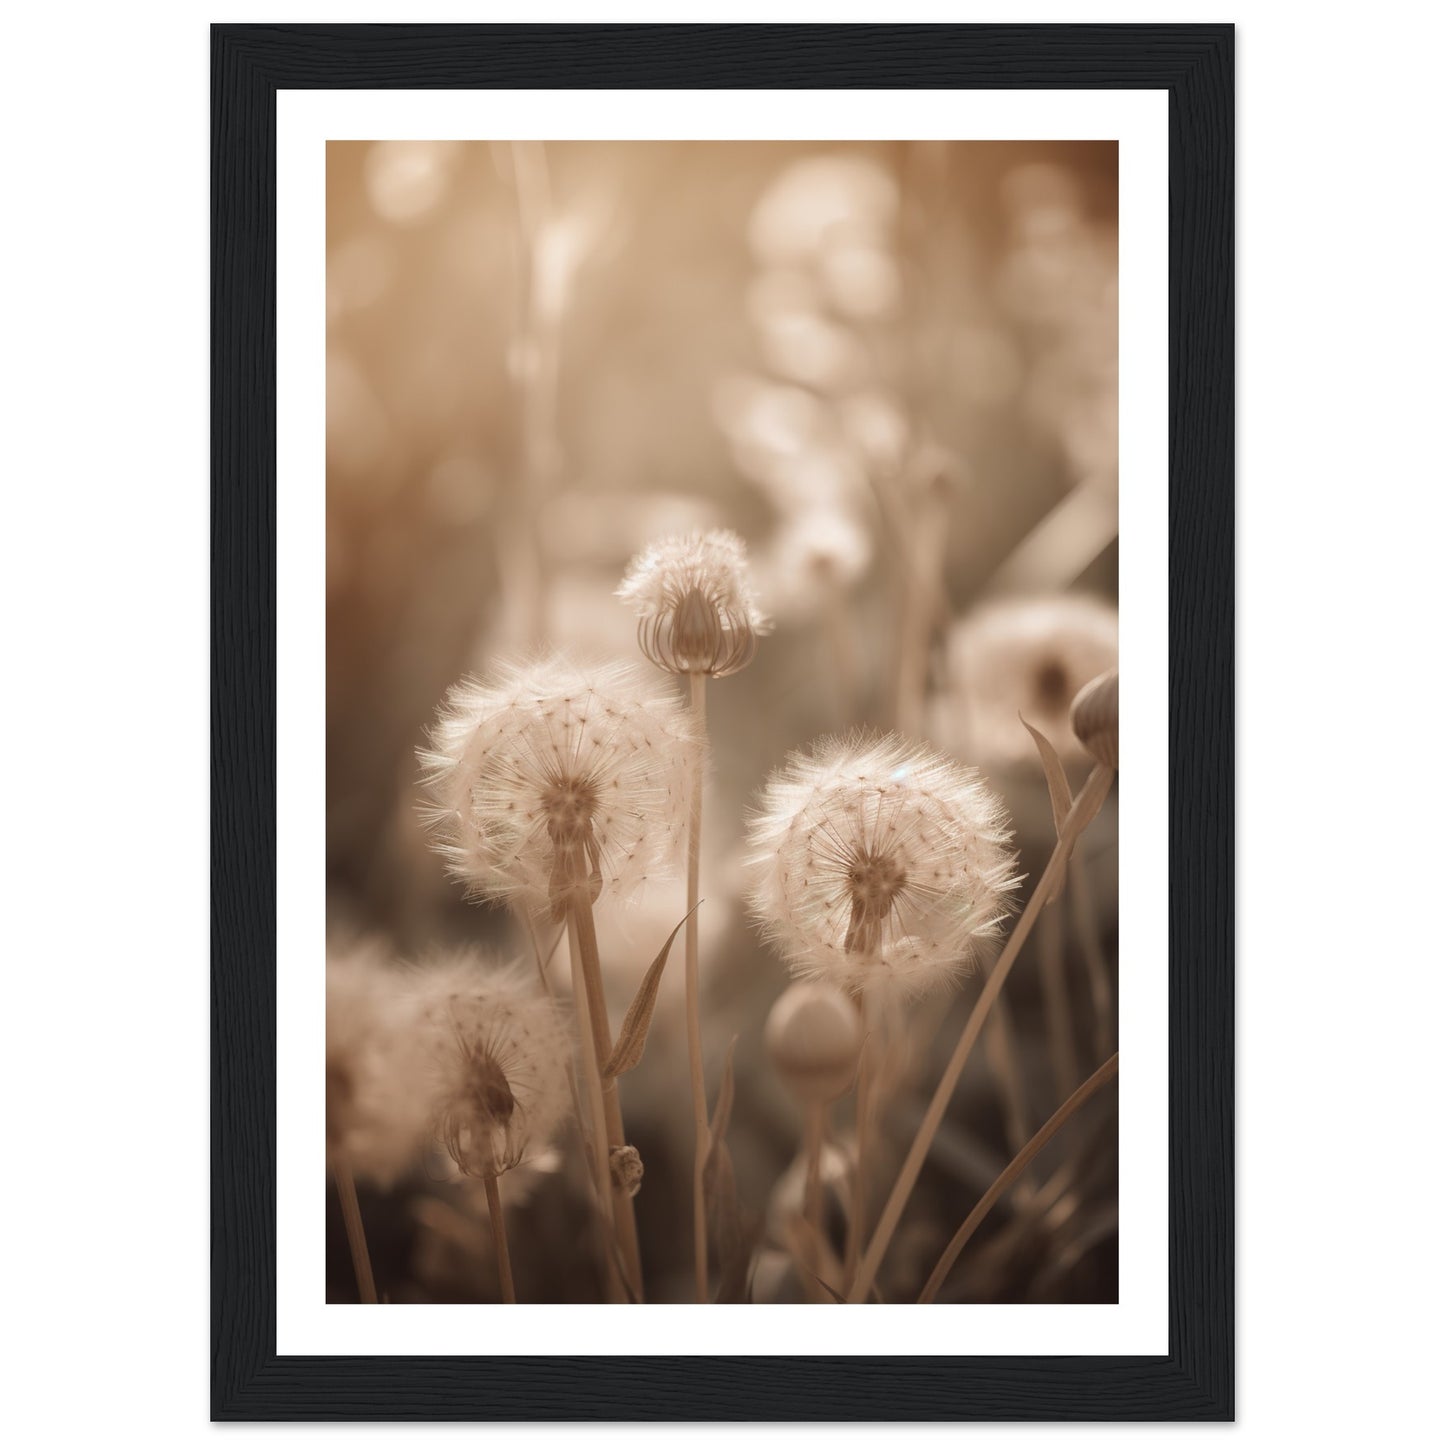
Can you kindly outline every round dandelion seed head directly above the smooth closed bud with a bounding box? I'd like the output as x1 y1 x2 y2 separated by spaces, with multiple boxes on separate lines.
747 736 1019 997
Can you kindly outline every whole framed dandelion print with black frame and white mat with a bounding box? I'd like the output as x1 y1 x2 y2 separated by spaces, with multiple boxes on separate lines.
212 25 1234 1420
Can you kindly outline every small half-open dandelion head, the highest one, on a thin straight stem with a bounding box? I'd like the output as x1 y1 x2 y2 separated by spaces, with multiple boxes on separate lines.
617 530 770 678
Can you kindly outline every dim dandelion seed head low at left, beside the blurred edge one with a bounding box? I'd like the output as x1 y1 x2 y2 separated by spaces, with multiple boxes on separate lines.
412 951 571 1179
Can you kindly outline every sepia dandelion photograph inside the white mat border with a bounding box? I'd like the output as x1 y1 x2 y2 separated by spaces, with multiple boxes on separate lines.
328 139 1127 1305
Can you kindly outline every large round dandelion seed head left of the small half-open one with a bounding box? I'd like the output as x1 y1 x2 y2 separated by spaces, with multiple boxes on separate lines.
419 656 701 918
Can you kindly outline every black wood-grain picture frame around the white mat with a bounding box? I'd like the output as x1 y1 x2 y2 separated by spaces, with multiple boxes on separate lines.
211 25 1234 1420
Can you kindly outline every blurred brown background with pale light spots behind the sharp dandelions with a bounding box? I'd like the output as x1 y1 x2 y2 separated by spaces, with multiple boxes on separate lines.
327 142 1118 1302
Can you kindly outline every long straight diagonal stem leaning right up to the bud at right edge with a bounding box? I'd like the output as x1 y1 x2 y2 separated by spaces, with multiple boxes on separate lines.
848 763 1114 1303
